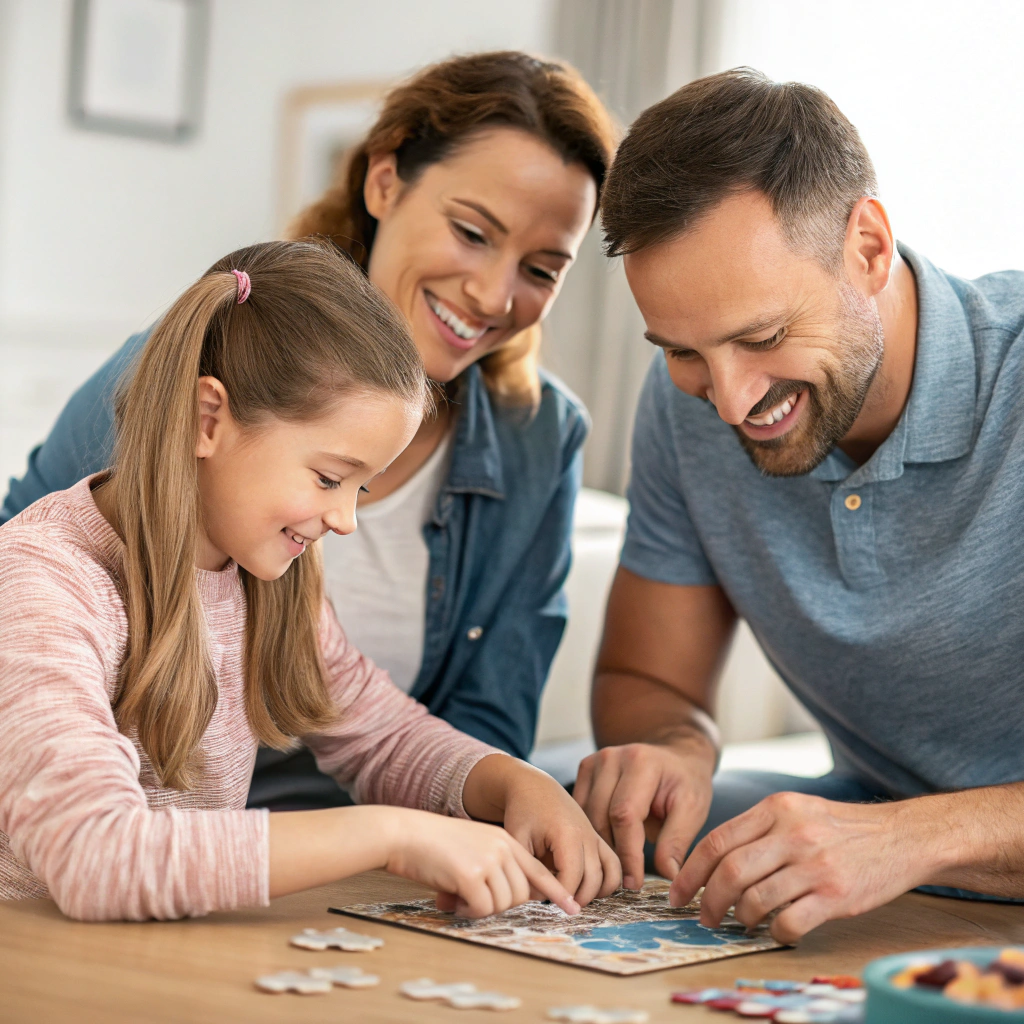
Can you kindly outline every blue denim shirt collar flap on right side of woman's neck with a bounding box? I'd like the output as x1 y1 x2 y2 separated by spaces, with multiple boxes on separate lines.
434 364 505 516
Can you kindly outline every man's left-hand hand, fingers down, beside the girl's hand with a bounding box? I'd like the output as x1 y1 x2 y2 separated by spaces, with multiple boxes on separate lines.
572 741 714 889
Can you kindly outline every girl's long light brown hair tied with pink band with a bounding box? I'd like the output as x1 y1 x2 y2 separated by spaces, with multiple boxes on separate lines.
113 242 428 790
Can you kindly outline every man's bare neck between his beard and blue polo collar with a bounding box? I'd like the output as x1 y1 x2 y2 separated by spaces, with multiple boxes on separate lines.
839 254 918 465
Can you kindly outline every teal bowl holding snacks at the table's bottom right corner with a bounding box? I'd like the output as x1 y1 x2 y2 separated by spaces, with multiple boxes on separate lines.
864 946 1024 1024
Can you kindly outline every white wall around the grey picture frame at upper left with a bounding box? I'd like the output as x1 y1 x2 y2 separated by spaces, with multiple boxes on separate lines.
0 0 550 344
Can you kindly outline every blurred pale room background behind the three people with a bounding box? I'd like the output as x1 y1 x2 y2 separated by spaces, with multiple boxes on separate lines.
0 0 1024 774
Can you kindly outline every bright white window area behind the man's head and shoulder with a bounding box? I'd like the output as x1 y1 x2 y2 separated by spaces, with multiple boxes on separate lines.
700 0 1024 276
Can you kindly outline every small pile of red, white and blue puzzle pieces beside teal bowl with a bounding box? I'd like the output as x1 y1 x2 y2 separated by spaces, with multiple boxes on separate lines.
672 976 866 1024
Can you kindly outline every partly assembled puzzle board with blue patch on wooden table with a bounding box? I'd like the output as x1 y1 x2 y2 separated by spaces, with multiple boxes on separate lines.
331 880 781 975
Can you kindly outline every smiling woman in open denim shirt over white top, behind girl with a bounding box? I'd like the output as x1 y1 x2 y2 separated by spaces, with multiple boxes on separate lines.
4 52 613 809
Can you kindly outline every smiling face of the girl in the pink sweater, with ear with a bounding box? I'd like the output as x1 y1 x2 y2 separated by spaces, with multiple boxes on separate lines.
196 377 422 580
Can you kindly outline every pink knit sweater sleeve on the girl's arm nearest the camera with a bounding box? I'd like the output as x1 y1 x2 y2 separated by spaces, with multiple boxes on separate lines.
0 522 268 921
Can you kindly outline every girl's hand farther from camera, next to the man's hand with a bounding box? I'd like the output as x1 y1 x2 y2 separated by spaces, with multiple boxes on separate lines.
462 755 623 906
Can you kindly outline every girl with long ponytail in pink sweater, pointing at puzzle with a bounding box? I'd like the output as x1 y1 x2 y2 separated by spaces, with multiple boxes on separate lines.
0 243 618 920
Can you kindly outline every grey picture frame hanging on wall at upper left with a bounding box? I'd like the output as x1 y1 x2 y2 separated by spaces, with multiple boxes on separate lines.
68 0 209 142
